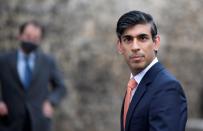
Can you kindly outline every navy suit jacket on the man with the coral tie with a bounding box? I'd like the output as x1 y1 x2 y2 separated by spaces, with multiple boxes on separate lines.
121 62 187 131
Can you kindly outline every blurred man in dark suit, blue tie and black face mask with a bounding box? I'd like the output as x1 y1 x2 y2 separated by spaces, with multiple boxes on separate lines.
0 21 65 131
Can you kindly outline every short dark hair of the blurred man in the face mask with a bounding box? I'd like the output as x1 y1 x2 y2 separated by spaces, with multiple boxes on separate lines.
19 20 45 38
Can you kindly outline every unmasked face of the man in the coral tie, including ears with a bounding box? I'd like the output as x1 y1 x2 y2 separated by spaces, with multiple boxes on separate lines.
117 24 160 75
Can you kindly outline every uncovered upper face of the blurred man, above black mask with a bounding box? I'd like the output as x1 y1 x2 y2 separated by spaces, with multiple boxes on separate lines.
19 24 42 44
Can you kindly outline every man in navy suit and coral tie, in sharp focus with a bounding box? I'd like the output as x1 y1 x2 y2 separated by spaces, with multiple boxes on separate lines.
116 11 187 131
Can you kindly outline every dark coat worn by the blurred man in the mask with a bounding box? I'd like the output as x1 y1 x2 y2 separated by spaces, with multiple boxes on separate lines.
0 51 65 131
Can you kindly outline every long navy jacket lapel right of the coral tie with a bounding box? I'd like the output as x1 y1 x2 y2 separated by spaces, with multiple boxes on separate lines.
125 62 164 131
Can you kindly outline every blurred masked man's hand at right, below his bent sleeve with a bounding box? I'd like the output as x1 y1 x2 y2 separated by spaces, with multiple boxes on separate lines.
43 101 54 118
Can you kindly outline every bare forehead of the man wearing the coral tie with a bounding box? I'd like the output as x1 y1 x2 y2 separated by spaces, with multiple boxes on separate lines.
123 24 151 36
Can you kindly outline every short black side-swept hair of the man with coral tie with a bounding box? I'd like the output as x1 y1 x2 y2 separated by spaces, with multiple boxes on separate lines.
116 10 157 40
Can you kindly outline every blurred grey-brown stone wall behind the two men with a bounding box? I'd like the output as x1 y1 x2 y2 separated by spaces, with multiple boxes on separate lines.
0 0 203 131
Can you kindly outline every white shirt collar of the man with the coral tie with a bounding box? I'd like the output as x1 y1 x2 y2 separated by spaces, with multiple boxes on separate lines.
130 57 158 84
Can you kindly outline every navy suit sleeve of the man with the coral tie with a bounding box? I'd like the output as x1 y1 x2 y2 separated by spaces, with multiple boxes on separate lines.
149 81 187 131
